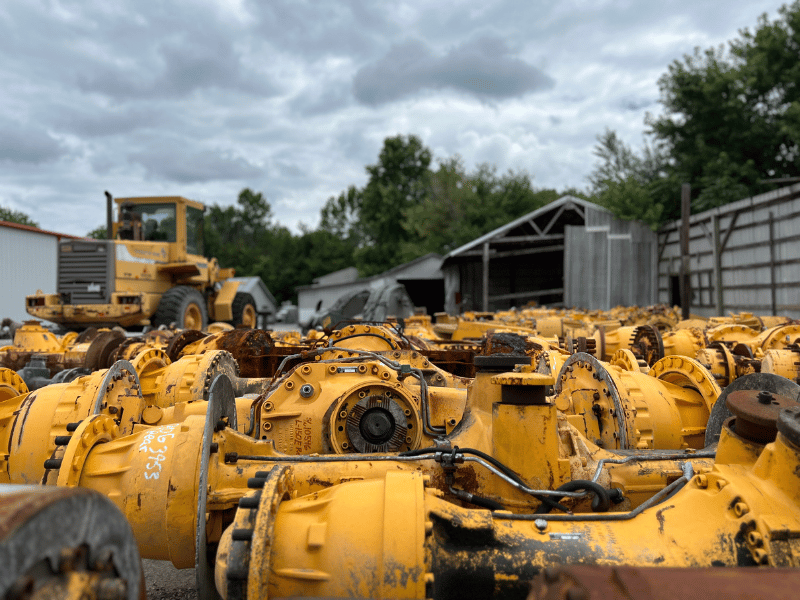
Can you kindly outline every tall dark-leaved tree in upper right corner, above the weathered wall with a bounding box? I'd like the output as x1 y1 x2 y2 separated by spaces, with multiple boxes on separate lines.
648 1 800 215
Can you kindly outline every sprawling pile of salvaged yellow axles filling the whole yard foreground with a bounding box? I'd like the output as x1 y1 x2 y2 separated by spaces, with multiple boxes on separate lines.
0 307 800 598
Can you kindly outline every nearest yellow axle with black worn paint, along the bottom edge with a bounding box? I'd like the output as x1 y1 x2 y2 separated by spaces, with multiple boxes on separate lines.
225 422 800 598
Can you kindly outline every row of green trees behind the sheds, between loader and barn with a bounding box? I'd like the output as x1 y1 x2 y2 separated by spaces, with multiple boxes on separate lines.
205 142 585 301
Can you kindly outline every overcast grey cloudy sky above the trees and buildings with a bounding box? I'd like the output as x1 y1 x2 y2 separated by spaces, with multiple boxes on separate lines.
0 0 782 235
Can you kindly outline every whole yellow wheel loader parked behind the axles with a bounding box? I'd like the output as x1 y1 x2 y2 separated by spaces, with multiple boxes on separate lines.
26 192 266 329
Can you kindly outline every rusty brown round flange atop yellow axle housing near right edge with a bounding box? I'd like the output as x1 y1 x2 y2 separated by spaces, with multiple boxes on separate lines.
726 390 797 444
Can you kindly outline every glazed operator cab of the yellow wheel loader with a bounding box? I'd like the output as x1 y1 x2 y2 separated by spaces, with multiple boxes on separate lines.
113 196 205 261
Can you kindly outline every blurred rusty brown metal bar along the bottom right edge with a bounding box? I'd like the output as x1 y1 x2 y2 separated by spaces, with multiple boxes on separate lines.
528 566 800 600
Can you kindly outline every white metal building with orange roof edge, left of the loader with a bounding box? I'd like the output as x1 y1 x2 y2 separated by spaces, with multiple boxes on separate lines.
0 221 78 322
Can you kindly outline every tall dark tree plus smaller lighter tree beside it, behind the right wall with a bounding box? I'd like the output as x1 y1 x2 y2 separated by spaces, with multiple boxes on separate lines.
589 1 800 229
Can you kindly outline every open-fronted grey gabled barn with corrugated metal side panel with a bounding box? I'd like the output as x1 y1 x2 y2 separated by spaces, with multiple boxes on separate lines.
442 196 658 314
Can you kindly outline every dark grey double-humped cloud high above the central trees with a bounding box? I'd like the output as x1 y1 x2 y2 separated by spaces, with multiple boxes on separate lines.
353 37 554 105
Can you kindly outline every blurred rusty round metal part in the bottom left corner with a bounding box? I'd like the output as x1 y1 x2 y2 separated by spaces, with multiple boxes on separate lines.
0 486 144 600
